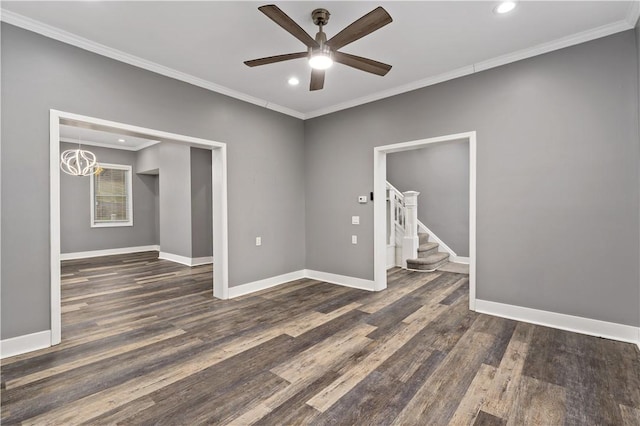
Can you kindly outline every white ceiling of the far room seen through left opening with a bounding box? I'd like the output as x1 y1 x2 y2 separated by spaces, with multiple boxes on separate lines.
60 124 160 151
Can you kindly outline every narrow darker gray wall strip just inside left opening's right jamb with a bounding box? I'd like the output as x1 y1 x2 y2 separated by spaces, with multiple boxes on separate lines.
191 147 213 258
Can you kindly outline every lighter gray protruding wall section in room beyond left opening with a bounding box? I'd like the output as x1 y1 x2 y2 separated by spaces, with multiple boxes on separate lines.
159 142 191 257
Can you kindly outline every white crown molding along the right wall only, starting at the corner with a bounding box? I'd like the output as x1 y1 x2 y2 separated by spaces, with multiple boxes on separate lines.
304 17 640 120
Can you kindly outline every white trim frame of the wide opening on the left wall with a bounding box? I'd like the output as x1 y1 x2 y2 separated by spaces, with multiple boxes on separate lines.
49 110 229 345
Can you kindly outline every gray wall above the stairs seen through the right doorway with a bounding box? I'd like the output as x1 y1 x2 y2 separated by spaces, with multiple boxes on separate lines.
387 141 469 257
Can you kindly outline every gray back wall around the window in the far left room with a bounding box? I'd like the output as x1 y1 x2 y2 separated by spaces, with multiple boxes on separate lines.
60 143 157 253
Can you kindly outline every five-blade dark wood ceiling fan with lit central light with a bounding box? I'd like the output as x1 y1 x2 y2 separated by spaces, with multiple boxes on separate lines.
245 4 393 90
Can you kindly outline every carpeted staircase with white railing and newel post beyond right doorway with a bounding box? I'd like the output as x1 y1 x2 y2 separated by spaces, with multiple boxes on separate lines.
387 182 456 271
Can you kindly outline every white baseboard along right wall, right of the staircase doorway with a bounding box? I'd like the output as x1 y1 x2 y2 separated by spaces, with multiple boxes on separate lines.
476 299 640 347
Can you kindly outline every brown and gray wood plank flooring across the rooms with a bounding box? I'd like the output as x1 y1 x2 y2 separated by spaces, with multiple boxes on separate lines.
1 252 640 425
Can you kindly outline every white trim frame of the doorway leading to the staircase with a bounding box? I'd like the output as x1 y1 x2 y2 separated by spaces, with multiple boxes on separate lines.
373 131 476 311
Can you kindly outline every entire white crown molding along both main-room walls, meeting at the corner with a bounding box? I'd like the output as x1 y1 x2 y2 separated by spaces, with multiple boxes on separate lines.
0 5 640 120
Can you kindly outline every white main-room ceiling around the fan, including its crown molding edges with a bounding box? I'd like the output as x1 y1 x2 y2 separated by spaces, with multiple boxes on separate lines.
2 1 640 118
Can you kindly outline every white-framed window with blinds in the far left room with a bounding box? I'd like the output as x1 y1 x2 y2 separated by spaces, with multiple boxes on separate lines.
91 164 133 228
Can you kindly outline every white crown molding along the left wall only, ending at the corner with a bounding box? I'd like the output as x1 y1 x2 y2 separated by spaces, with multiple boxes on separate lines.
0 9 304 119
